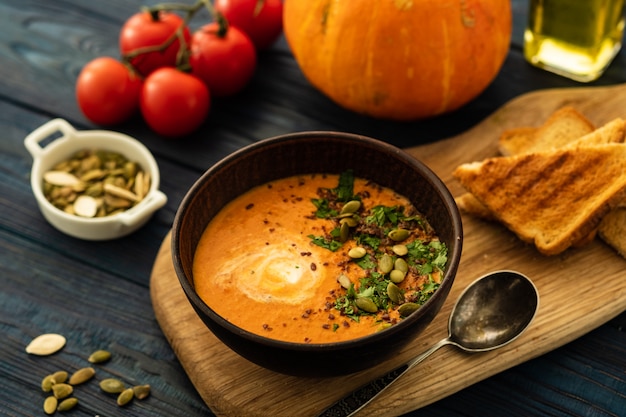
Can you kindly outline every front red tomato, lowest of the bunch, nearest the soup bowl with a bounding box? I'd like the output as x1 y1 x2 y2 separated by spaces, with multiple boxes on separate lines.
139 67 211 137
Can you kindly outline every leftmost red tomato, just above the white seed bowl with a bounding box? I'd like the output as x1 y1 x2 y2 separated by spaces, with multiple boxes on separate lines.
76 57 143 125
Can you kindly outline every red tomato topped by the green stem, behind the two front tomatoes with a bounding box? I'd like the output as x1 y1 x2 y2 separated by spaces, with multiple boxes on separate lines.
119 11 191 76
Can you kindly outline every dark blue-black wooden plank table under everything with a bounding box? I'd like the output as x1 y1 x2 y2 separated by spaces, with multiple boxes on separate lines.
0 0 626 417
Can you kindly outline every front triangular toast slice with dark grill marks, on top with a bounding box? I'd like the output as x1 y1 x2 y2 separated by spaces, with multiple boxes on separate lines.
454 144 626 255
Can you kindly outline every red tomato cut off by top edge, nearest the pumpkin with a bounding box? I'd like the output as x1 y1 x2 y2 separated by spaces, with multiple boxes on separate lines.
214 0 282 50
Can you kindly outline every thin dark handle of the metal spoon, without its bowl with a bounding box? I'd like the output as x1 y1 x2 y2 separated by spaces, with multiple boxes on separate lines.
317 338 451 417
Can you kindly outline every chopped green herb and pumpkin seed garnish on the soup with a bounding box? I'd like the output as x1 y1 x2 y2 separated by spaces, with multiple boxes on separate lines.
308 171 448 331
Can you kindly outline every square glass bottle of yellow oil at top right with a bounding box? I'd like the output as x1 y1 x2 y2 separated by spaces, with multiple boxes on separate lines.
524 0 624 82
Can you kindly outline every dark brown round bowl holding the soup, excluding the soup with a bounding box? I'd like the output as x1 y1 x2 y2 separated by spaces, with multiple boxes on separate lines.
172 132 463 376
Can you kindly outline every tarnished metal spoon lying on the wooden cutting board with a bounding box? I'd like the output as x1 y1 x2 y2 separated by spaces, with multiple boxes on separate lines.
318 270 539 417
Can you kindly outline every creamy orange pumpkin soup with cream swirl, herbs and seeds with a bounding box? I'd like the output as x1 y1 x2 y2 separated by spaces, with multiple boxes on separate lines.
193 171 447 343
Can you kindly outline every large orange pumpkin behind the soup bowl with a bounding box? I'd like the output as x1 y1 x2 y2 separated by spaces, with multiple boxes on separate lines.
283 0 512 120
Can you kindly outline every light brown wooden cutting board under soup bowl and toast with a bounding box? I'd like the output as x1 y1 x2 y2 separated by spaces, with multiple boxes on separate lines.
151 85 626 417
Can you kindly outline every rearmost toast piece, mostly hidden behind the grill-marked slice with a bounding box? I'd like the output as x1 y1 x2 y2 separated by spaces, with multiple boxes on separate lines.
498 106 595 156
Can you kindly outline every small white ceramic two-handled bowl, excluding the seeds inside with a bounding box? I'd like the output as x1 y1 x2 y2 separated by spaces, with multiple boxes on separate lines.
24 119 167 240
